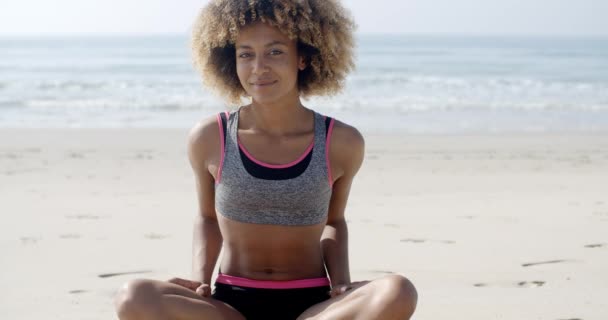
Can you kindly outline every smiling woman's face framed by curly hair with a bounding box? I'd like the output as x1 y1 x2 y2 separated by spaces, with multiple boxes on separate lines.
236 22 306 103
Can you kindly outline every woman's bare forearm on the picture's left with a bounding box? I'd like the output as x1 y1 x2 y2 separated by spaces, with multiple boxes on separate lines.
192 216 222 284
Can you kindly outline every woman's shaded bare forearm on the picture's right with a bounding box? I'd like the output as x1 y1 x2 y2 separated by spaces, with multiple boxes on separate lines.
321 220 350 285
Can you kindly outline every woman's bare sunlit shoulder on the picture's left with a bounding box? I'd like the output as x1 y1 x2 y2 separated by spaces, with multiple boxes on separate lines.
188 115 220 171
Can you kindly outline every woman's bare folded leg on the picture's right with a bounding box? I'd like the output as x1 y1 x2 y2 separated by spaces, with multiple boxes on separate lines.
298 274 418 320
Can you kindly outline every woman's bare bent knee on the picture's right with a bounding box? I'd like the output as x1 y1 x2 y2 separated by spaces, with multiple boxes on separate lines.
378 274 418 319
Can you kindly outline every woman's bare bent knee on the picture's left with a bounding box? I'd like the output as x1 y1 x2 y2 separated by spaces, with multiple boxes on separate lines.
114 279 159 320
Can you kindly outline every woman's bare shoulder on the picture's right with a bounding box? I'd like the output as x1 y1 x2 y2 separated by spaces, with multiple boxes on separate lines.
329 120 365 178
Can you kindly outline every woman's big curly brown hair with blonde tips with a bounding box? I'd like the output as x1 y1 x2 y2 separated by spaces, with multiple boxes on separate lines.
192 0 355 102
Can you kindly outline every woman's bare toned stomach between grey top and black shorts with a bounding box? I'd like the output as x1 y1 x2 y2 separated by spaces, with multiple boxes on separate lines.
218 214 326 280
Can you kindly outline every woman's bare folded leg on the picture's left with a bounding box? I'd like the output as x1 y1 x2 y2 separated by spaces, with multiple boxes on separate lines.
115 279 245 320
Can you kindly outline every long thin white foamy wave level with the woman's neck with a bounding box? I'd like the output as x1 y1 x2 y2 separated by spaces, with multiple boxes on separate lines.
14 95 608 115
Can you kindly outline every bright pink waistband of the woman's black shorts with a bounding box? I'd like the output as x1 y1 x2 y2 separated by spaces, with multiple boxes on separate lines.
216 273 330 289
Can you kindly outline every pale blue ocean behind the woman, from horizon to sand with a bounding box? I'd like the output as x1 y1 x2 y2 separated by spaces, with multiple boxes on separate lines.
0 35 608 134
